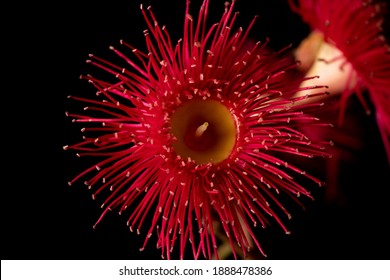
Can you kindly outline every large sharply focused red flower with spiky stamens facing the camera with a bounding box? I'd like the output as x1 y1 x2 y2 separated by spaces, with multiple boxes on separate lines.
65 0 329 259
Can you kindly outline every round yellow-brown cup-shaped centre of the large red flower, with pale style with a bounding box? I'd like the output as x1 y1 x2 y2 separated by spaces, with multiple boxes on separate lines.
171 100 237 164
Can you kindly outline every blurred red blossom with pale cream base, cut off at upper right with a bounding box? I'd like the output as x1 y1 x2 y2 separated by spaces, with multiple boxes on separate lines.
289 0 390 161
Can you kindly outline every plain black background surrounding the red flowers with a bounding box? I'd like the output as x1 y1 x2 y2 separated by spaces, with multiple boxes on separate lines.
1 0 390 259
